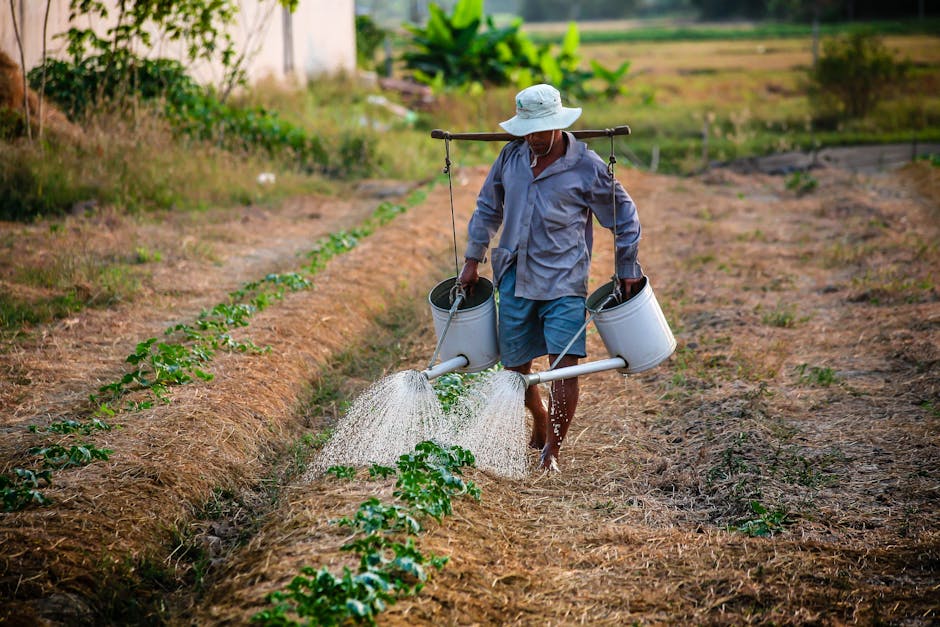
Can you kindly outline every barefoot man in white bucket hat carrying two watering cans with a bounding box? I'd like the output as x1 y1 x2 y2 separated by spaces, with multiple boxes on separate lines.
459 84 643 471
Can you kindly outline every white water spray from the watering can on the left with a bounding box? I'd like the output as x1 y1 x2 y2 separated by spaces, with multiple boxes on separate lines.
315 370 448 470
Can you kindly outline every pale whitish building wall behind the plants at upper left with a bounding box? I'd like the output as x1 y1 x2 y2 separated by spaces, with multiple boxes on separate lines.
0 0 356 84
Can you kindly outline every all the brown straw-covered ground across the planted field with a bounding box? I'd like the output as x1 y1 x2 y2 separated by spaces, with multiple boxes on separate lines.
0 163 940 625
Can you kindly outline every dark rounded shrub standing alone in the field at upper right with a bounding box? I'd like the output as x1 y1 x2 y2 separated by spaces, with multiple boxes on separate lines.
809 32 910 118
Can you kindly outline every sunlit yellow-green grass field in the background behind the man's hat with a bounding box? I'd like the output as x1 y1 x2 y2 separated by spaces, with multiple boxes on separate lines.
370 31 940 175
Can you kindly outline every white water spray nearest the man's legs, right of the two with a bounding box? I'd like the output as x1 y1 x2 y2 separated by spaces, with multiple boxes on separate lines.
449 370 529 479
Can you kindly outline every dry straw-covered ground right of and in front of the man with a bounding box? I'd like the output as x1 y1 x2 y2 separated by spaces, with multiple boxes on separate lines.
191 164 940 625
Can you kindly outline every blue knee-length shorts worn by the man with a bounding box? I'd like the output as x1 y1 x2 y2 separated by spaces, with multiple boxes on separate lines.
498 265 586 368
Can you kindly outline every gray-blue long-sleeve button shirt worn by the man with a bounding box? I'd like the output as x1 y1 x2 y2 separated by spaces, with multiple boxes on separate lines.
466 133 643 300
